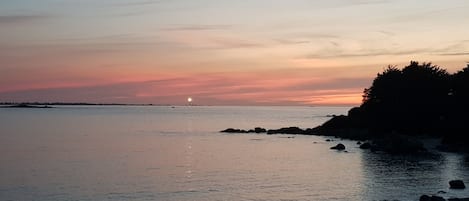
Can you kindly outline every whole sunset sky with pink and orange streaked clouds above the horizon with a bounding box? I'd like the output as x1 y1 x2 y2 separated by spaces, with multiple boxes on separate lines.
0 0 469 106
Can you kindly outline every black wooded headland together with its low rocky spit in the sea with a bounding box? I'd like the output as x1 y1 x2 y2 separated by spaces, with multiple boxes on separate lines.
222 61 469 153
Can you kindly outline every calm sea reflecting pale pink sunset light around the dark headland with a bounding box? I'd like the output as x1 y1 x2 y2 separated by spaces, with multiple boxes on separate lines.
0 106 469 201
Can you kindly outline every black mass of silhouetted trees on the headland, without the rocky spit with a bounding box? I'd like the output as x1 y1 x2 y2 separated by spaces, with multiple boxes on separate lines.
350 61 469 141
